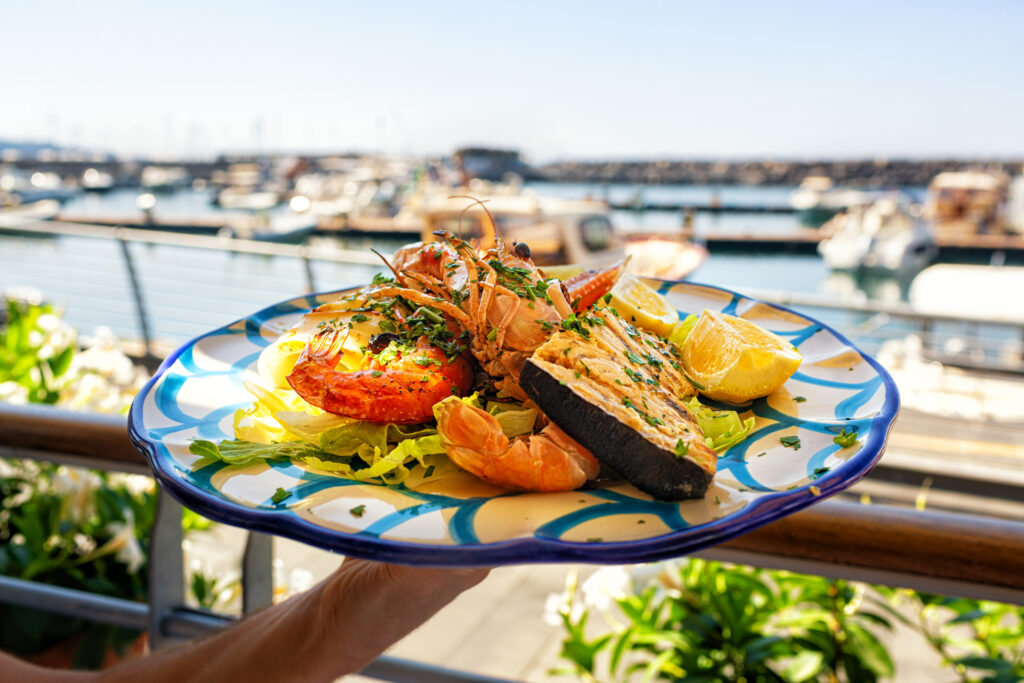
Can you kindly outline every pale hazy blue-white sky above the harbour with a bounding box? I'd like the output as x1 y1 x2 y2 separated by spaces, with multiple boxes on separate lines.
0 0 1024 161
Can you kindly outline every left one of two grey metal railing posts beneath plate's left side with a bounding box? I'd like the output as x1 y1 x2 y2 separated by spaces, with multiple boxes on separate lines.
150 487 185 650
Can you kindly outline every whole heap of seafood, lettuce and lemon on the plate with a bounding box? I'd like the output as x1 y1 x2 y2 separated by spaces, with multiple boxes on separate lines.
190 206 799 500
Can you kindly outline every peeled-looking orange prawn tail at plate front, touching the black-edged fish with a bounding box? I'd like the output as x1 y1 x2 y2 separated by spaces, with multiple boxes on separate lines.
434 397 600 493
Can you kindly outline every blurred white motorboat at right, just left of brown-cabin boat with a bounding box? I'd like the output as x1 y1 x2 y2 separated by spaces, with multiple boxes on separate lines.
818 198 939 274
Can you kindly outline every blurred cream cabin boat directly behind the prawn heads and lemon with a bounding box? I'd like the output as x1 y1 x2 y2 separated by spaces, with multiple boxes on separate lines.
394 188 708 280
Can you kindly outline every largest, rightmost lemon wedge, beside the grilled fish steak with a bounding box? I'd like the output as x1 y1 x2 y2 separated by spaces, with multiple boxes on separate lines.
682 310 803 403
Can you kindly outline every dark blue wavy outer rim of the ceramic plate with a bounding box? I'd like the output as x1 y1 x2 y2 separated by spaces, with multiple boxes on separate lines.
128 279 900 566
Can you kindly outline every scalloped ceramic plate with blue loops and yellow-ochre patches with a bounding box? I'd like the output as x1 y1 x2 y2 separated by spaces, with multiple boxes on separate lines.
129 282 899 566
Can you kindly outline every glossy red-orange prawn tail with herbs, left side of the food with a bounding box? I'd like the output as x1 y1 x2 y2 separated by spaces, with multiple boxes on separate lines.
288 329 473 424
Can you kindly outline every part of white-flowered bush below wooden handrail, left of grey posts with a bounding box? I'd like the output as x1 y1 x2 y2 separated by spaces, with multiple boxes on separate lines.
0 461 156 669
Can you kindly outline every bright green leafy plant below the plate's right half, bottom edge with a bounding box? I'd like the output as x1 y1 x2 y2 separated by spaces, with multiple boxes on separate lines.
556 559 894 682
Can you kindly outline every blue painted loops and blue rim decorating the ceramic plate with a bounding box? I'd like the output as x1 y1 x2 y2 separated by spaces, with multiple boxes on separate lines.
129 283 899 565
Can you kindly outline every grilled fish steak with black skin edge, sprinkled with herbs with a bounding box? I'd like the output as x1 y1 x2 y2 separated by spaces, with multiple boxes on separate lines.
519 306 717 501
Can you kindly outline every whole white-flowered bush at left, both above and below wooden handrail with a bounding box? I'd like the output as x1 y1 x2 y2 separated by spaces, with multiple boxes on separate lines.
0 298 226 669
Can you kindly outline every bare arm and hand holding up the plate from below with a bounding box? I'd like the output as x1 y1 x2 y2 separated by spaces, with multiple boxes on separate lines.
0 559 487 683
